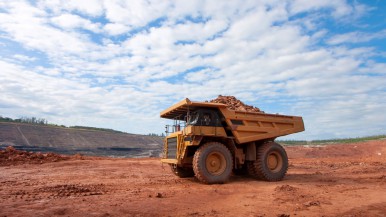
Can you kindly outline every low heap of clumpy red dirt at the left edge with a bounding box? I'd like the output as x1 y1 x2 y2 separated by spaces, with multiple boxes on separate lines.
0 146 70 166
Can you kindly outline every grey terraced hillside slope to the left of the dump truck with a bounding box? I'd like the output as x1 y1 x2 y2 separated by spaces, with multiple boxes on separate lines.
0 122 162 157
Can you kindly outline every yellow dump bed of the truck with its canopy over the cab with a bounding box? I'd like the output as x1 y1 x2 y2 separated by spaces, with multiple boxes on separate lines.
160 99 304 144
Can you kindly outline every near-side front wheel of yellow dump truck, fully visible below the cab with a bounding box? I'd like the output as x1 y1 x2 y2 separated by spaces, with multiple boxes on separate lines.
193 142 233 184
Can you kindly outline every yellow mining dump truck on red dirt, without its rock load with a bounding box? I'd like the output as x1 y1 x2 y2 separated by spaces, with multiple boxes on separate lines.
160 99 304 184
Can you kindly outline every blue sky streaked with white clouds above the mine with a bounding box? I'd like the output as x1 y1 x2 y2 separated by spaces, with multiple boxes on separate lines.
0 0 386 140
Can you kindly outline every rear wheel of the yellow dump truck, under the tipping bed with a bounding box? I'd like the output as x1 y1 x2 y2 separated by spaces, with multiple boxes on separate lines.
247 142 288 182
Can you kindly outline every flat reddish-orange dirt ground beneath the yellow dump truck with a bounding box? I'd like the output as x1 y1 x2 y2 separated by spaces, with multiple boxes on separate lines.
0 140 386 217
